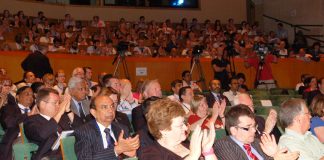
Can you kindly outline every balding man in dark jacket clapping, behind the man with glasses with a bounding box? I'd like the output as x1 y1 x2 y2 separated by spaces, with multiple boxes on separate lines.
233 93 281 142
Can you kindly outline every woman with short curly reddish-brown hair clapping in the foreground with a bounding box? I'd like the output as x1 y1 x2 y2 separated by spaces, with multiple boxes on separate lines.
139 99 217 160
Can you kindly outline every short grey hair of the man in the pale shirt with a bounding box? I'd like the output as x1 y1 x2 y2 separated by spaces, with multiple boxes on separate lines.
279 98 306 128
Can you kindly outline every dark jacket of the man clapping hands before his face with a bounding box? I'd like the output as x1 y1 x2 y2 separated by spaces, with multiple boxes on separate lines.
24 114 82 159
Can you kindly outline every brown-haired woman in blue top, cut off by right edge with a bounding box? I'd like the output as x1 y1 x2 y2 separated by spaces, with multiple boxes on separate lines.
310 94 324 143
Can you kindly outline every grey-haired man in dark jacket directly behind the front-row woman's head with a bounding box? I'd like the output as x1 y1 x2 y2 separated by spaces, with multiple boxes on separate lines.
132 80 162 132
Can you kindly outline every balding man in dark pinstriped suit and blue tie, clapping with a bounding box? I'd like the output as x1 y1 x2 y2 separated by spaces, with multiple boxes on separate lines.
74 95 139 160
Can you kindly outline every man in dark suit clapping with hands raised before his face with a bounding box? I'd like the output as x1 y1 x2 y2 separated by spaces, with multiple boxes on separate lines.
24 88 82 159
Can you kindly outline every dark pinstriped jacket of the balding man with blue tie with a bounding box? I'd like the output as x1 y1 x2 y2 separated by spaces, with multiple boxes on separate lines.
74 120 129 160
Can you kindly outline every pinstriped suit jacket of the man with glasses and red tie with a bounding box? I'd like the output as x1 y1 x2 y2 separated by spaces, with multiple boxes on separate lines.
213 136 272 160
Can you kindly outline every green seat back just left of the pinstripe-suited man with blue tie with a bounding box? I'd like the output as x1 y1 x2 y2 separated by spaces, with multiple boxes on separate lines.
60 136 77 160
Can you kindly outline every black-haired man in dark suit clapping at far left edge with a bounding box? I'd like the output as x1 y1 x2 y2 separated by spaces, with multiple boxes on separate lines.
0 86 37 159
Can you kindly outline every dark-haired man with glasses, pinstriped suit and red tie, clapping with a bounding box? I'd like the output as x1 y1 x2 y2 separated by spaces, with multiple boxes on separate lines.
213 105 298 160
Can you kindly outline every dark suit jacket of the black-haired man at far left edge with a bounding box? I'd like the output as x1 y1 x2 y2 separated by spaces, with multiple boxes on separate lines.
0 104 28 159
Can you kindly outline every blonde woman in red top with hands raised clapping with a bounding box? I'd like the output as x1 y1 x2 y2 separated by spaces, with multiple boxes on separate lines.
188 95 226 129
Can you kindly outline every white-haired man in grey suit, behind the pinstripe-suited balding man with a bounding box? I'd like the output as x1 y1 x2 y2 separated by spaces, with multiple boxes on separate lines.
68 77 92 122
